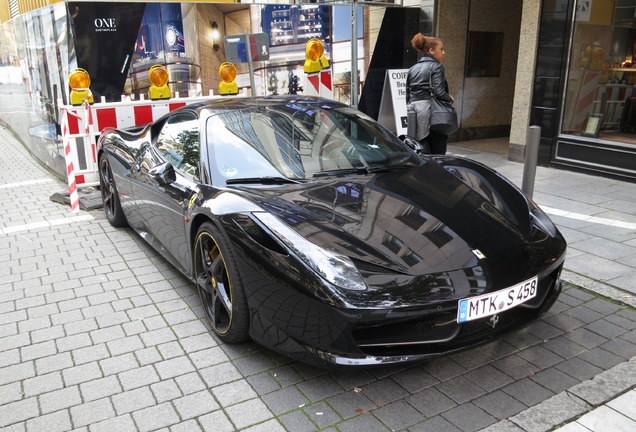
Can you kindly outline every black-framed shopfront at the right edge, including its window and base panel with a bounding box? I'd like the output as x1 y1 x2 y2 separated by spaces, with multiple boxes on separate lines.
531 0 636 181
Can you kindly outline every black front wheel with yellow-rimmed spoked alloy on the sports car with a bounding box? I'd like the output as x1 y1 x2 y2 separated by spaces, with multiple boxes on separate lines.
194 222 249 343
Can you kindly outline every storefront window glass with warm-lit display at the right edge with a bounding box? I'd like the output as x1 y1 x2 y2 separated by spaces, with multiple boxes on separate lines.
562 0 636 145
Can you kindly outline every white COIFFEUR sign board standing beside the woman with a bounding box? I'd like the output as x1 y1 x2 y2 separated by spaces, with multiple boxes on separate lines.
378 69 409 136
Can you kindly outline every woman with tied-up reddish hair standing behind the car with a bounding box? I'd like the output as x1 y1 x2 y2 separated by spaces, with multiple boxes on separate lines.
406 33 453 154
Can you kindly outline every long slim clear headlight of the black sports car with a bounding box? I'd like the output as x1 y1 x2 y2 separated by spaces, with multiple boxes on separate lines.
253 212 367 291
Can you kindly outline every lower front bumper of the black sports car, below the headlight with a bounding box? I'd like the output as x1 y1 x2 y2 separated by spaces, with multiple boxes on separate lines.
247 266 562 367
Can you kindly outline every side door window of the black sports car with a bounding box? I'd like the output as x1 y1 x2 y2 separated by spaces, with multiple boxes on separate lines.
155 112 199 181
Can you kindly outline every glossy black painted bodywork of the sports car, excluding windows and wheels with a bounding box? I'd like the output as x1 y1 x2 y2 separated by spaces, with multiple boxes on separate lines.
99 97 566 366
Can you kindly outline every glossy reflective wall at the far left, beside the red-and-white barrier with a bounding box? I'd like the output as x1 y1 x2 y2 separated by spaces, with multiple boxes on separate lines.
0 3 69 179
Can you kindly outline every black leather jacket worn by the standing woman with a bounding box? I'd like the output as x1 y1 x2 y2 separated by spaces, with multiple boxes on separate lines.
406 55 453 104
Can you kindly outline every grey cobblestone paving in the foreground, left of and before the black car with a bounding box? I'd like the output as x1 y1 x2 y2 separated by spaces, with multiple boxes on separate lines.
0 127 636 432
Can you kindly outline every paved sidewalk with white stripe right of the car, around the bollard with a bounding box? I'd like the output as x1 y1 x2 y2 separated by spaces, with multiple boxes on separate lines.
449 139 636 300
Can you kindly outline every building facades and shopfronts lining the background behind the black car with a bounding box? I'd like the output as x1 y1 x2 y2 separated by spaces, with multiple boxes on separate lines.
0 0 636 180
